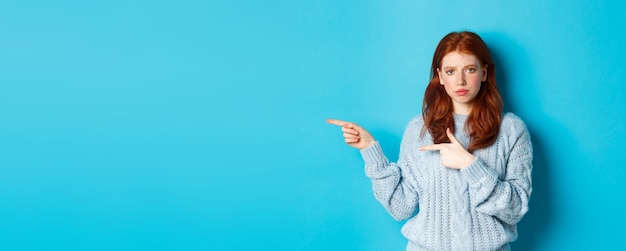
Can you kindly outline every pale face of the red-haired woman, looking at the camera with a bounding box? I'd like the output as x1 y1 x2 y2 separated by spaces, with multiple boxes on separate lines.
437 51 487 115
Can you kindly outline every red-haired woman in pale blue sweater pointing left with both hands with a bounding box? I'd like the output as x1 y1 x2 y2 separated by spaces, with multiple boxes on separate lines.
328 31 533 250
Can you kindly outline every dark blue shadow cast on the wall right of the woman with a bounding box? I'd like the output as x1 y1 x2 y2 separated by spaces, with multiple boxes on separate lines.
482 33 552 250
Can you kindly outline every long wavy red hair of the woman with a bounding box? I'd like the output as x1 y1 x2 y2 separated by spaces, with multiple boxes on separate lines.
422 31 503 152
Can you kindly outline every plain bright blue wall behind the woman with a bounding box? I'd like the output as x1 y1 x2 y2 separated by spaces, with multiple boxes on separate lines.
0 0 626 250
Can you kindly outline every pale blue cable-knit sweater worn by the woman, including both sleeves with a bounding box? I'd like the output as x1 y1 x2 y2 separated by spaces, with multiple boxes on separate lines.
361 113 533 250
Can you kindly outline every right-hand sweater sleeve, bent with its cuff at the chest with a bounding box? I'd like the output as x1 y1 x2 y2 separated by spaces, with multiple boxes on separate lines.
461 117 533 225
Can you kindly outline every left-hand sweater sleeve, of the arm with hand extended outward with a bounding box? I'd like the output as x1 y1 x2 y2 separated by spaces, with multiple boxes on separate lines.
361 121 418 221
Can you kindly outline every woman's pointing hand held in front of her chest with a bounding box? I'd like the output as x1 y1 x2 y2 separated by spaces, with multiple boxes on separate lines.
419 128 475 169
